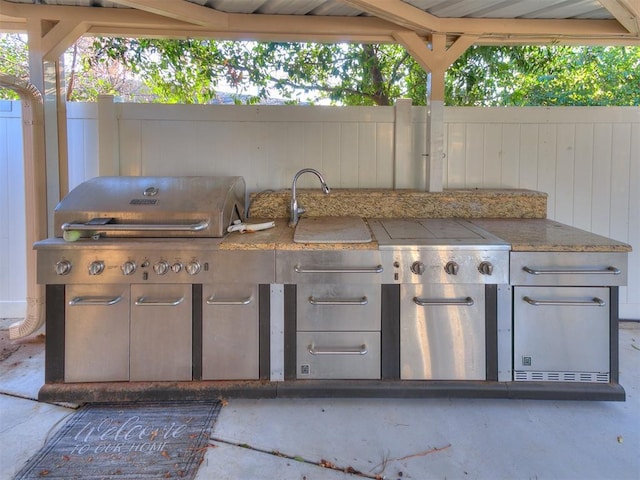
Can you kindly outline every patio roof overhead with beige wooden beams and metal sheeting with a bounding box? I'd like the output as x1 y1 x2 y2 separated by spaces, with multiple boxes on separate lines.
0 0 640 53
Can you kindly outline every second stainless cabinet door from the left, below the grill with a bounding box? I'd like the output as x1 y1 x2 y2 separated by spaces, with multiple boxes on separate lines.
130 284 192 381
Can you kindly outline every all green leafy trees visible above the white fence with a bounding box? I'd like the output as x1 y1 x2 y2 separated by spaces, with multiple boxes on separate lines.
0 35 640 106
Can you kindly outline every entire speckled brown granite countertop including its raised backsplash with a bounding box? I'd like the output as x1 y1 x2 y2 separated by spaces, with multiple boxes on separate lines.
220 189 631 252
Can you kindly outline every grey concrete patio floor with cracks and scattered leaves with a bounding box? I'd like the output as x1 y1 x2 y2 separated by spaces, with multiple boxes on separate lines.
0 320 640 480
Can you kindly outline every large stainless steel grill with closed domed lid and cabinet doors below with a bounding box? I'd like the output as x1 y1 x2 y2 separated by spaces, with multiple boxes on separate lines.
35 177 251 383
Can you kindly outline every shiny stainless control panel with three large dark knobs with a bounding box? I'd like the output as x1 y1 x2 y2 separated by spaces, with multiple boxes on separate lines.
380 247 509 284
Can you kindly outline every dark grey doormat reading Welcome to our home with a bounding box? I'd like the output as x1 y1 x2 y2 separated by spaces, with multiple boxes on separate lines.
15 401 221 480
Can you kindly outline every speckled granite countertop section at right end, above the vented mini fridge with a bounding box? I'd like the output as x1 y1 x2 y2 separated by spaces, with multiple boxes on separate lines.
472 219 631 252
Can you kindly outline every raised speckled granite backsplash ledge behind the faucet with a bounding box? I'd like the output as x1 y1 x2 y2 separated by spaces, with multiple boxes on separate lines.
249 189 547 218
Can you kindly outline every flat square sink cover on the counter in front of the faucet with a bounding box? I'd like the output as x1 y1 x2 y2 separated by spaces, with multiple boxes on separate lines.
293 217 371 243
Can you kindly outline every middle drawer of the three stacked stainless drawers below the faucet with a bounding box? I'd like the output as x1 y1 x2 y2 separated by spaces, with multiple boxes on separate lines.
296 284 381 331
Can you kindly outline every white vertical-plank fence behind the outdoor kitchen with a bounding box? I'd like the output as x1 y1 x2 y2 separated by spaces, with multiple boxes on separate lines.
0 100 640 319
